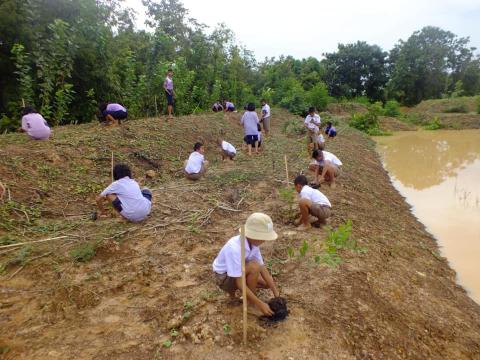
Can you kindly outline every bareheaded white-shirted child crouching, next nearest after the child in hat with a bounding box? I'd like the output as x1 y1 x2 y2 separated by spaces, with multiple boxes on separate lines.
294 175 332 230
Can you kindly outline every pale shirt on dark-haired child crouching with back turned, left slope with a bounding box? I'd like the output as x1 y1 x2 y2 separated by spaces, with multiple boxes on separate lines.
100 176 152 222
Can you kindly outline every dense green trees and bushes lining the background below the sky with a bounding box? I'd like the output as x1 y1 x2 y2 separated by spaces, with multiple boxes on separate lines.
0 0 480 132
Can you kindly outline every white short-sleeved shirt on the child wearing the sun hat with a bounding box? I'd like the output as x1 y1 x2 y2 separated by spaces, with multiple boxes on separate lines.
212 235 263 277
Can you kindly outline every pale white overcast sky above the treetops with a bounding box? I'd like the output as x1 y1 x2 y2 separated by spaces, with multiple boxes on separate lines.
125 0 480 61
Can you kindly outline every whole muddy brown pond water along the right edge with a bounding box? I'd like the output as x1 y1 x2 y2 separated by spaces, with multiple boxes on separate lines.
375 130 480 303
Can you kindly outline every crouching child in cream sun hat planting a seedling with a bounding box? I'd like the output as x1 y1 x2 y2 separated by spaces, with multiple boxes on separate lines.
212 213 280 316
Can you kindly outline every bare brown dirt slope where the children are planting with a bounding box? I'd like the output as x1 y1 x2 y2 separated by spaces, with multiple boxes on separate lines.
0 110 480 360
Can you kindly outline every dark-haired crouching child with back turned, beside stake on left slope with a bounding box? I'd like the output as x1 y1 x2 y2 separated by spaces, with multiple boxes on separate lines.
96 164 152 222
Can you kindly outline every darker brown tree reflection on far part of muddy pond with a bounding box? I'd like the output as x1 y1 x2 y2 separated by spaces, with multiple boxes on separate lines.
377 130 480 190
